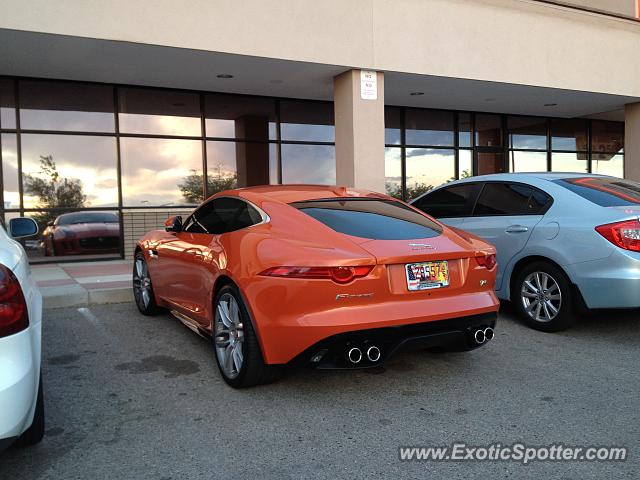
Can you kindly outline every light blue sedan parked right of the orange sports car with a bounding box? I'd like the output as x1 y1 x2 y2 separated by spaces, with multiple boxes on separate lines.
411 173 640 331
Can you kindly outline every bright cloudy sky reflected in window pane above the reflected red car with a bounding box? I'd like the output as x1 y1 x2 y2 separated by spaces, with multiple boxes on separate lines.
22 134 118 208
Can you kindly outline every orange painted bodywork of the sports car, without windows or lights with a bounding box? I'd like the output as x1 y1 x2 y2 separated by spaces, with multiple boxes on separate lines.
138 185 499 364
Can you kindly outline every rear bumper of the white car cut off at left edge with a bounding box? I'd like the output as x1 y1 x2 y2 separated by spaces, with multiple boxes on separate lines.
0 323 40 443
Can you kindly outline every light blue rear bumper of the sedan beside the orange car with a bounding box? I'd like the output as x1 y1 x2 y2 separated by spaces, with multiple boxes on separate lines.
565 248 640 308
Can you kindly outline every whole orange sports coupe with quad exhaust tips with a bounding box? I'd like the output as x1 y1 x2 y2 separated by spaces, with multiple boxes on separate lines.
133 185 499 387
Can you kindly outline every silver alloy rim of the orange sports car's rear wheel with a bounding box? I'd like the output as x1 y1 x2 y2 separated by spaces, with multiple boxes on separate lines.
214 293 244 379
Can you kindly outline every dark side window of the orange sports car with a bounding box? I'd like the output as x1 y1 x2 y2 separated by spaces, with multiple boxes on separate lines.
185 198 262 235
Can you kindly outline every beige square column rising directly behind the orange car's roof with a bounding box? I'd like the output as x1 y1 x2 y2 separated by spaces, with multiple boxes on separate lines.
333 70 385 193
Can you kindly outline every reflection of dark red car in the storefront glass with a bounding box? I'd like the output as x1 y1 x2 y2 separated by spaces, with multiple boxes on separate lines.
42 212 120 257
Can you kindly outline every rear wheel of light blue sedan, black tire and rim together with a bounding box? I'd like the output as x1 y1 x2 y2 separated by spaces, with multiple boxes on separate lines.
511 260 577 332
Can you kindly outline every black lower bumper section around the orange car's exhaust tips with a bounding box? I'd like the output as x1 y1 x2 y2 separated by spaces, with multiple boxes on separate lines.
290 313 497 369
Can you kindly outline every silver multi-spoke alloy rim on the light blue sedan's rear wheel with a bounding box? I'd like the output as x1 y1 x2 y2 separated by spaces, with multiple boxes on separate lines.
520 272 562 322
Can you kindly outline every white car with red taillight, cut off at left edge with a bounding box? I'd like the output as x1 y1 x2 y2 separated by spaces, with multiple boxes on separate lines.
0 218 44 450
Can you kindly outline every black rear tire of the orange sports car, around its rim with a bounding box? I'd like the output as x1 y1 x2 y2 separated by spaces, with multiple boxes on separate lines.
212 285 278 388
